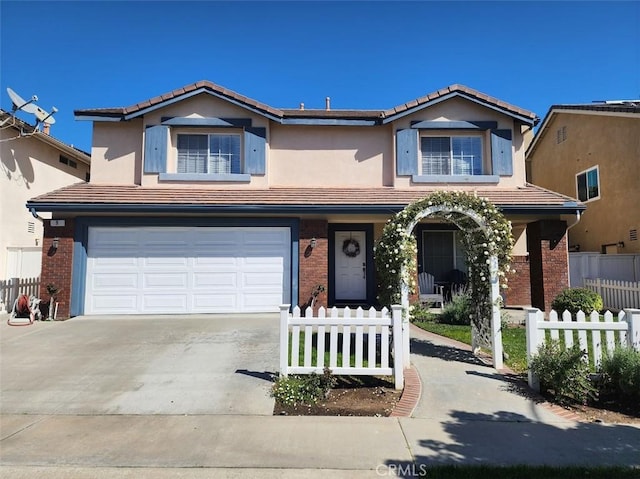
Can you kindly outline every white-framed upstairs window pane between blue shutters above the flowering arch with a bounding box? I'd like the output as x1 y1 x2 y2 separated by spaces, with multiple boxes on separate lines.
420 136 483 175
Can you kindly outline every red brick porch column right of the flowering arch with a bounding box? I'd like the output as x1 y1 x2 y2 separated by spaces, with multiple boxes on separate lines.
527 220 569 311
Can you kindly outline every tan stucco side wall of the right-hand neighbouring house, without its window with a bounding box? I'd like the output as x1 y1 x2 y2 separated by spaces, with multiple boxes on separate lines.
528 113 640 253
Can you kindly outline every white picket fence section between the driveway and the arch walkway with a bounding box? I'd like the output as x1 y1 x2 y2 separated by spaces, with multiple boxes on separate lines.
280 304 404 389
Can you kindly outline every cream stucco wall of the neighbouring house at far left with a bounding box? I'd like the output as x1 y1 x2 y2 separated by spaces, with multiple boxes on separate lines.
0 128 89 279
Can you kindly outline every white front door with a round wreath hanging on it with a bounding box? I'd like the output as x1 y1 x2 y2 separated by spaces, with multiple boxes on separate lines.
334 231 367 302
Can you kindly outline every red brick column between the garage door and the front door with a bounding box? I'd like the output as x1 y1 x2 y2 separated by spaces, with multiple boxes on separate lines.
298 220 329 309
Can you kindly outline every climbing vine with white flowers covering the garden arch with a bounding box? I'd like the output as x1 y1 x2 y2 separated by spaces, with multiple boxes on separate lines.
375 191 513 342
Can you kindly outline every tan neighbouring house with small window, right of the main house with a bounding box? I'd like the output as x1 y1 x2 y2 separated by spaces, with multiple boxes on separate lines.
526 100 640 254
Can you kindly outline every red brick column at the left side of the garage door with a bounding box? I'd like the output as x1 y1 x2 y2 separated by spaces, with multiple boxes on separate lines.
40 219 75 319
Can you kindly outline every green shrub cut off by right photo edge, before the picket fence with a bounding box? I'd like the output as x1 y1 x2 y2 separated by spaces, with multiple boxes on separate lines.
600 347 640 400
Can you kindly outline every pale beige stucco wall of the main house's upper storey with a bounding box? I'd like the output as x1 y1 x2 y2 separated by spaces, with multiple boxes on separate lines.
87 94 525 189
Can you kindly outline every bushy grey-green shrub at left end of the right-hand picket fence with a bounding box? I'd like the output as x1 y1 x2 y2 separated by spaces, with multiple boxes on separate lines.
530 341 595 404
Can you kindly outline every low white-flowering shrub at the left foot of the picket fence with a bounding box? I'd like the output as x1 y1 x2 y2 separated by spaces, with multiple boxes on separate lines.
271 368 336 406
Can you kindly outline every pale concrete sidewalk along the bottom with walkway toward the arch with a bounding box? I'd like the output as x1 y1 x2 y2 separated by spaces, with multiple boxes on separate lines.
0 316 640 479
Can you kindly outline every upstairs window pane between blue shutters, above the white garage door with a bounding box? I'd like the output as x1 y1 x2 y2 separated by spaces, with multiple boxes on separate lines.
177 134 242 174
